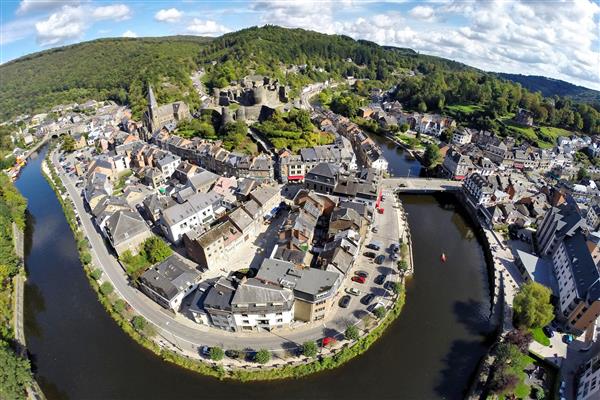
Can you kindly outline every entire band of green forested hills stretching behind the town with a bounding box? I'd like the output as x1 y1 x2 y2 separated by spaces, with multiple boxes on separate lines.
0 26 600 134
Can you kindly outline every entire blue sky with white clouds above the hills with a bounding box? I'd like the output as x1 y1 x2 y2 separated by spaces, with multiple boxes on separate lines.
0 0 600 90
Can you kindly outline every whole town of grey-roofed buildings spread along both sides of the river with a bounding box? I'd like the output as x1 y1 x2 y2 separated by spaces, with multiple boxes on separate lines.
3 71 600 398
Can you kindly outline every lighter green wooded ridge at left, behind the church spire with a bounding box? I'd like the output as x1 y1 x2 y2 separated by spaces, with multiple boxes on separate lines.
0 37 208 119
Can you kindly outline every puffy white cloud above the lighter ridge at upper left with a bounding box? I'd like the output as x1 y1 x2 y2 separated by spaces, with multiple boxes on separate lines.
35 6 86 46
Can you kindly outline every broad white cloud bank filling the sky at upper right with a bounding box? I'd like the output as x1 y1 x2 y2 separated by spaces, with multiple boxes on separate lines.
328 0 600 90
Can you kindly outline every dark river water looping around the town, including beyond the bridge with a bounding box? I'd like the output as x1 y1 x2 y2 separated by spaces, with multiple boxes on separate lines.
16 142 494 400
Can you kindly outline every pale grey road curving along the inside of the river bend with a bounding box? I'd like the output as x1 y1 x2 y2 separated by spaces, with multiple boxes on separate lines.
51 153 404 357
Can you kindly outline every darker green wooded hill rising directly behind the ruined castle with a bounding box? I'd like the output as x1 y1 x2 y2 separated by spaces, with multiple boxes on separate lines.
199 26 471 93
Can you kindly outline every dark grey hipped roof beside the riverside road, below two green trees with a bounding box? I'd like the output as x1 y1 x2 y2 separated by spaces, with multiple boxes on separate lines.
141 253 200 300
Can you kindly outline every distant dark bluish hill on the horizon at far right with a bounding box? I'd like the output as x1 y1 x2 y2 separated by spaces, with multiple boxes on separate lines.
498 73 600 103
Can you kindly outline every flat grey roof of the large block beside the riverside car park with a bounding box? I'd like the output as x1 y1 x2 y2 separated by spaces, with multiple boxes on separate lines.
256 258 340 300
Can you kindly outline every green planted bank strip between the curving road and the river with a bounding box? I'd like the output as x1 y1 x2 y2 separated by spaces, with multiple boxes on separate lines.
42 145 412 381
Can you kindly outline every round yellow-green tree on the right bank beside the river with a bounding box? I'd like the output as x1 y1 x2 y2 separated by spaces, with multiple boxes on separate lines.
513 282 554 329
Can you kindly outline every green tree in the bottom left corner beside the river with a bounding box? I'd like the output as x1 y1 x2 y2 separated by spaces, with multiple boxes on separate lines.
0 341 33 399
